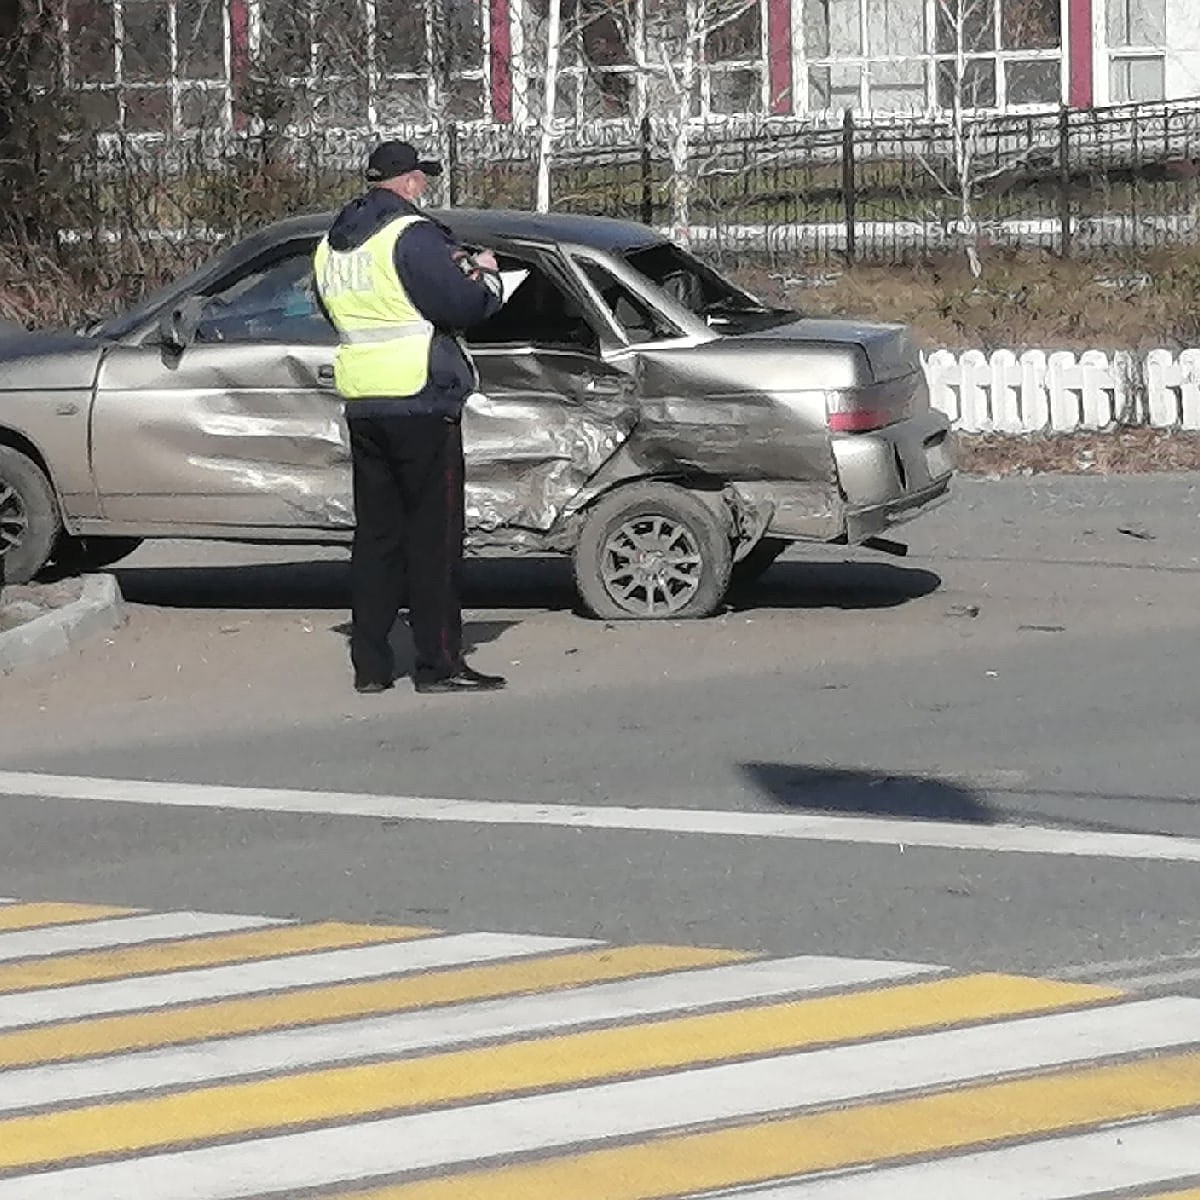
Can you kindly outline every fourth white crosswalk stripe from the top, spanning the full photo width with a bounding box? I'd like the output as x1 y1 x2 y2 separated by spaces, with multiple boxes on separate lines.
0 1000 1200 1200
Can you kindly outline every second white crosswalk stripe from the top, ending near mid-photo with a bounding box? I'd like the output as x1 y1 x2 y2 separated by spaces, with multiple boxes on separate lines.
0 934 598 1030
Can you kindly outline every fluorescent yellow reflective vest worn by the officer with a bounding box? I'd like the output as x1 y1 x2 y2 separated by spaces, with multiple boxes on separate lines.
313 216 433 400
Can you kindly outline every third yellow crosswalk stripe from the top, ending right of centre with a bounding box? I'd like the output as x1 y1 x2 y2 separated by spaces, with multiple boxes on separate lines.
0 946 749 1068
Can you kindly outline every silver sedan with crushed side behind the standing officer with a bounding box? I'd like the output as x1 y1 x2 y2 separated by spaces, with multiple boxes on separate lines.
0 210 954 619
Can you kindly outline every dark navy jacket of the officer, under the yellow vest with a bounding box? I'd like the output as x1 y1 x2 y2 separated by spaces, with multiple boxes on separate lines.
329 187 500 418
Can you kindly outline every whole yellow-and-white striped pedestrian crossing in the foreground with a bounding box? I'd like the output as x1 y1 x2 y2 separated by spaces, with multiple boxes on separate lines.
0 900 1200 1200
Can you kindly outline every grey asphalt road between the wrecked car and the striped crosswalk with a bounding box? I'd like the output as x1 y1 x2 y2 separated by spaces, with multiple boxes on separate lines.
0 476 1200 991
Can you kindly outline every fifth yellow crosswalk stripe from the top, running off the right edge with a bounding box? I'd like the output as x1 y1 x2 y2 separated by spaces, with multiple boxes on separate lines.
344 1054 1200 1200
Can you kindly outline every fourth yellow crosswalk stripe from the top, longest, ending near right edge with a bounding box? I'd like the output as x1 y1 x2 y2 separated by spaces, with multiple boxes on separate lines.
0 976 1116 1171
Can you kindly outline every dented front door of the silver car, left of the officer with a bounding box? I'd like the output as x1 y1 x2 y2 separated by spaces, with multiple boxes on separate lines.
92 247 354 530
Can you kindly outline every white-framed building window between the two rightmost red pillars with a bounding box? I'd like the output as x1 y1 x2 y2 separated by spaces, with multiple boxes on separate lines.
803 0 1063 113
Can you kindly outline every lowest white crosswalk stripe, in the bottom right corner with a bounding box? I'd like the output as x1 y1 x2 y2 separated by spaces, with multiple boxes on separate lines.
716 1116 1200 1200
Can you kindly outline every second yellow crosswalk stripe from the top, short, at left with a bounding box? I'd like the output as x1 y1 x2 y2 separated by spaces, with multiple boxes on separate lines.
0 922 436 995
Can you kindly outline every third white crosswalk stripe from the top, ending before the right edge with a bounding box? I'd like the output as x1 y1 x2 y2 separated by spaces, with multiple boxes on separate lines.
0 958 937 1111
